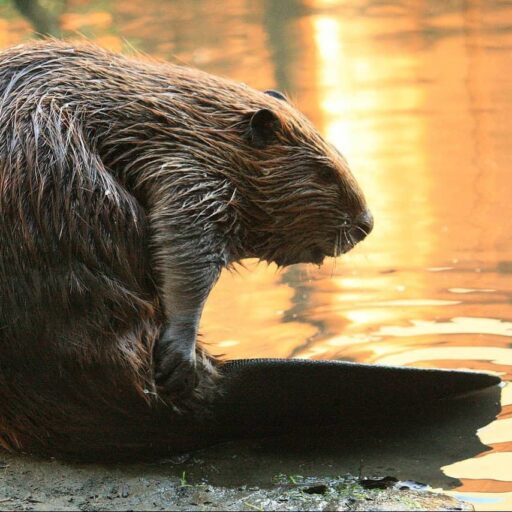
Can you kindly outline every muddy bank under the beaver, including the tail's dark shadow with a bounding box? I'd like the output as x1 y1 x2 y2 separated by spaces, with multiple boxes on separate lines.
0 389 499 510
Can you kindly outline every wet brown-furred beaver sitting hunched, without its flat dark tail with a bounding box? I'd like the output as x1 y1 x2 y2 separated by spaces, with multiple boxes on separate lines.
0 40 373 459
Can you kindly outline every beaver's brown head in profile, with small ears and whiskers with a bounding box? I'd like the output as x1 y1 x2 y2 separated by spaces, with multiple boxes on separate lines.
236 91 373 266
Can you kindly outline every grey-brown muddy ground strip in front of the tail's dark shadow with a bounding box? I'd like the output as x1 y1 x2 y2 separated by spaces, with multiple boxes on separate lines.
0 451 472 511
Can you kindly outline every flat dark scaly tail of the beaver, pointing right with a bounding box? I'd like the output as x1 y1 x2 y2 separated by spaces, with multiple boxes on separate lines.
213 359 500 437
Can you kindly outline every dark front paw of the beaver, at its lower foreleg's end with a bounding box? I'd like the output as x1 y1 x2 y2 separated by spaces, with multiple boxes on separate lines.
155 332 199 398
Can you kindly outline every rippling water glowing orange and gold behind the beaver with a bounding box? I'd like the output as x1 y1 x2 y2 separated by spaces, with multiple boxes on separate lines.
0 0 512 510
